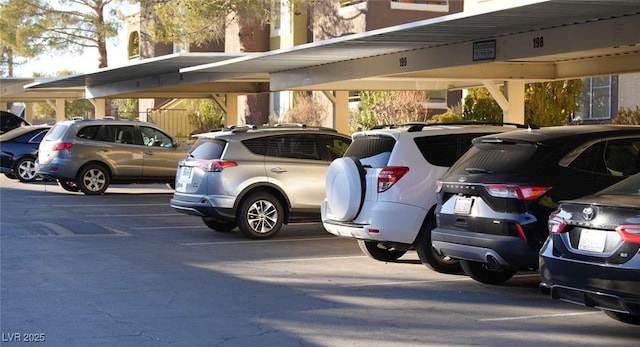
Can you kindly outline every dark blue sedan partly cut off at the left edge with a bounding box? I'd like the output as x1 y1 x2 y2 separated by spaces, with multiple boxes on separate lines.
0 125 51 182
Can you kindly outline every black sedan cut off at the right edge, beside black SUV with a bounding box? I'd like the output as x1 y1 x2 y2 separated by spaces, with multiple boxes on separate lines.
540 173 640 325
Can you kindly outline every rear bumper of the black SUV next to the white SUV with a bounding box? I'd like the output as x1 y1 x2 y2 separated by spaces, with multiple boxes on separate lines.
431 228 538 269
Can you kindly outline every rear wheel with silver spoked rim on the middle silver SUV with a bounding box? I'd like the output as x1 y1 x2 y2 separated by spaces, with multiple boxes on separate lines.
236 193 284 239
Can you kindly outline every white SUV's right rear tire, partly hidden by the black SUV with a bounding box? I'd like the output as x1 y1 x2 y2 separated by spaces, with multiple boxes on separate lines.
416 216 462 274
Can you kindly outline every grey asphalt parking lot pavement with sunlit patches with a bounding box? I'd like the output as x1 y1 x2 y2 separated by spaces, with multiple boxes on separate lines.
0 176 640 347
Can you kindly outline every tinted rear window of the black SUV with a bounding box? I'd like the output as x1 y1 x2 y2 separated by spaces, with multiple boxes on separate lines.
449 143 538 175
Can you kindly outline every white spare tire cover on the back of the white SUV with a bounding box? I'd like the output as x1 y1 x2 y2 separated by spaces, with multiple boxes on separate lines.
325 157 366 221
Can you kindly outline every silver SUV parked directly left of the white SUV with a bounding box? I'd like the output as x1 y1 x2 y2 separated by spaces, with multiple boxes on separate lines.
171 125 351 239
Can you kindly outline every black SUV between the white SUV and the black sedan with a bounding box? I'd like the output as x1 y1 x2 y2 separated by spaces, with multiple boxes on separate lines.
432 125 640 284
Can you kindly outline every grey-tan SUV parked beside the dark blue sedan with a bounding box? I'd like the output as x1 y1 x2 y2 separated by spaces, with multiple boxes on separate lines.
36 119 188 195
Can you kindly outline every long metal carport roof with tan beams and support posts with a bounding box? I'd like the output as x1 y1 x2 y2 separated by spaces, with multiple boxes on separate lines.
20 0 640 132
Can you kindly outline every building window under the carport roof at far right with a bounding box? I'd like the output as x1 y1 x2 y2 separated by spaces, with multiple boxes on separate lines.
573 76 617 121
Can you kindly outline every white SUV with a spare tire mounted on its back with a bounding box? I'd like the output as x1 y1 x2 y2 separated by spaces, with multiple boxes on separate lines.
321 123 515 273
